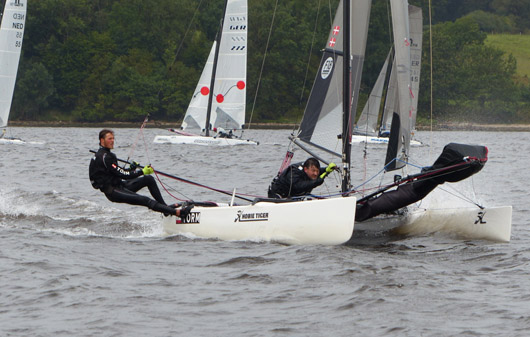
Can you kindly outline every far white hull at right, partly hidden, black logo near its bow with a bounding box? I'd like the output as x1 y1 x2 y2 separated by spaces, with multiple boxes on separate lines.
355 206 512 242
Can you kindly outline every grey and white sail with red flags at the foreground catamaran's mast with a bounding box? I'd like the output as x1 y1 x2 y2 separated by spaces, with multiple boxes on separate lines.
298 0 371 157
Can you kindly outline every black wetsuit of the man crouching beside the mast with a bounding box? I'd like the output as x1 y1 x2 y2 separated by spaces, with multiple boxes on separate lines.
269 163 326 198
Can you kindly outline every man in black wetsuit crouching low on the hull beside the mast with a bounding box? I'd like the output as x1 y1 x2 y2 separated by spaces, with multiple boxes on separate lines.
269 158 337 198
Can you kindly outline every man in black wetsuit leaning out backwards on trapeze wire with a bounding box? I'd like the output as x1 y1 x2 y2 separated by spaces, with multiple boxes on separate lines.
89 129 192 218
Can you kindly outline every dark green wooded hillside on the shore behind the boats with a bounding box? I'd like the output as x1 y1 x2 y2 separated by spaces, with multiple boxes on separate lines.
11 0 530 123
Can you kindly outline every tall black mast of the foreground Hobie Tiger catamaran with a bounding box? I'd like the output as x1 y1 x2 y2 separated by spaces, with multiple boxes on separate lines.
341 0 351 192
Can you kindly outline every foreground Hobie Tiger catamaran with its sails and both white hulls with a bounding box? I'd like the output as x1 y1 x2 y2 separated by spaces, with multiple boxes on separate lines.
163 0 511 245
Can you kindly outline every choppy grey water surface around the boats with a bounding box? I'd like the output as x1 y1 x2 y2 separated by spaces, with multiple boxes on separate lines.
0 128 530 336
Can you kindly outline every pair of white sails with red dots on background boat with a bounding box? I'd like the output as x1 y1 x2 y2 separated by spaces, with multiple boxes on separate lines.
182 0 248 132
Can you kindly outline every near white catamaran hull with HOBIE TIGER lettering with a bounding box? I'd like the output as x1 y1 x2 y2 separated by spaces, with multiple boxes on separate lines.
163 197 356 245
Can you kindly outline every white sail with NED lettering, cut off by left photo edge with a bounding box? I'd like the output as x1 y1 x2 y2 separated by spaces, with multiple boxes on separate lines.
0 0 27 127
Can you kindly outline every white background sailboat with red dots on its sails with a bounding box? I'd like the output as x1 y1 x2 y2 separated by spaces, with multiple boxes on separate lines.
154 0 257 146
